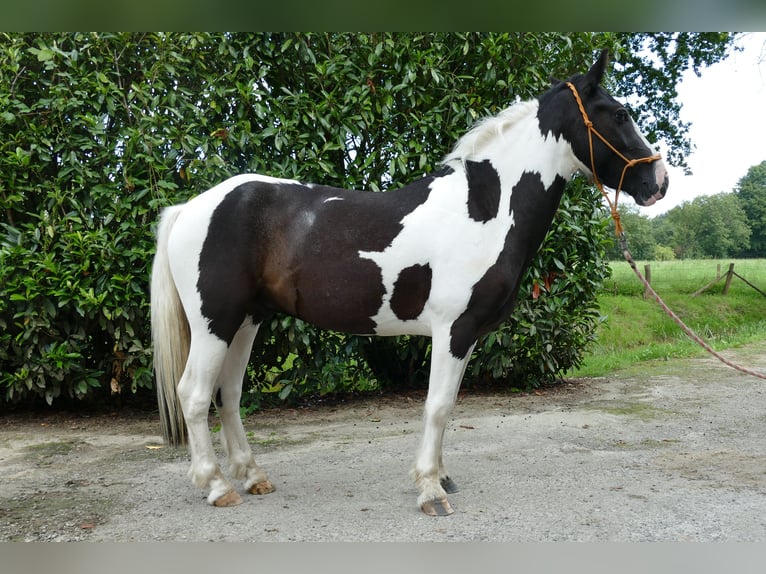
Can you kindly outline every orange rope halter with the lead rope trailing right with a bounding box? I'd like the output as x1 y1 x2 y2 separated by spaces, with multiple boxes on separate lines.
567 82 766 380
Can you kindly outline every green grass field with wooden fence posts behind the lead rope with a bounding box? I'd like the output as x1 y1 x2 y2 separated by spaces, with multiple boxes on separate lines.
568 259 766 376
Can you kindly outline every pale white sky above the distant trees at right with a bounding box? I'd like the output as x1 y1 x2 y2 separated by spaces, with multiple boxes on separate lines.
639 32 766 217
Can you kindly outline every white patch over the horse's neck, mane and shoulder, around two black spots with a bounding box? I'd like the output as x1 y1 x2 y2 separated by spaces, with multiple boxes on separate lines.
359 101 580 335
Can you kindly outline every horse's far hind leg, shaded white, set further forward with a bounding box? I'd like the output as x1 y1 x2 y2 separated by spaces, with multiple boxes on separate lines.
218 323 274 494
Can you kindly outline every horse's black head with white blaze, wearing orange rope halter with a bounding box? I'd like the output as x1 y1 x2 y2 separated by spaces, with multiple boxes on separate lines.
539 50 668 206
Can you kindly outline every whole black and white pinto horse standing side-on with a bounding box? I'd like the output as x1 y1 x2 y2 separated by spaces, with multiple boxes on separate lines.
151 52 668 515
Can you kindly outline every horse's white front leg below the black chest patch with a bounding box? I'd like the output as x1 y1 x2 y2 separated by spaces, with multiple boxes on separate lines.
413 336 473 516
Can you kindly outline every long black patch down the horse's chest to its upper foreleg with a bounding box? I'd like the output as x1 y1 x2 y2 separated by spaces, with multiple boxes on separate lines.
450 172 566 359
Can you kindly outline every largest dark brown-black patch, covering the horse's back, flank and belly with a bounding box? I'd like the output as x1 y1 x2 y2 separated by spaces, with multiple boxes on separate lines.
197 176 434 344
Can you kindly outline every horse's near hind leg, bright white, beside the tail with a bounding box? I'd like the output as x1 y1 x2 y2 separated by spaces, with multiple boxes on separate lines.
178 329 242 506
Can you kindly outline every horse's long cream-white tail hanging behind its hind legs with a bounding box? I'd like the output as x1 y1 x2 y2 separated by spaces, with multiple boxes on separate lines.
151 206 191 446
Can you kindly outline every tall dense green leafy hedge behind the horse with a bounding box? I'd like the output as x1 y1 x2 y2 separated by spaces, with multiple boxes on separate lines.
0 33 615 406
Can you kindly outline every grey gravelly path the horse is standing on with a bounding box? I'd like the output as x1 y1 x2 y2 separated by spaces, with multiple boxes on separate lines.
0 345 766 541
